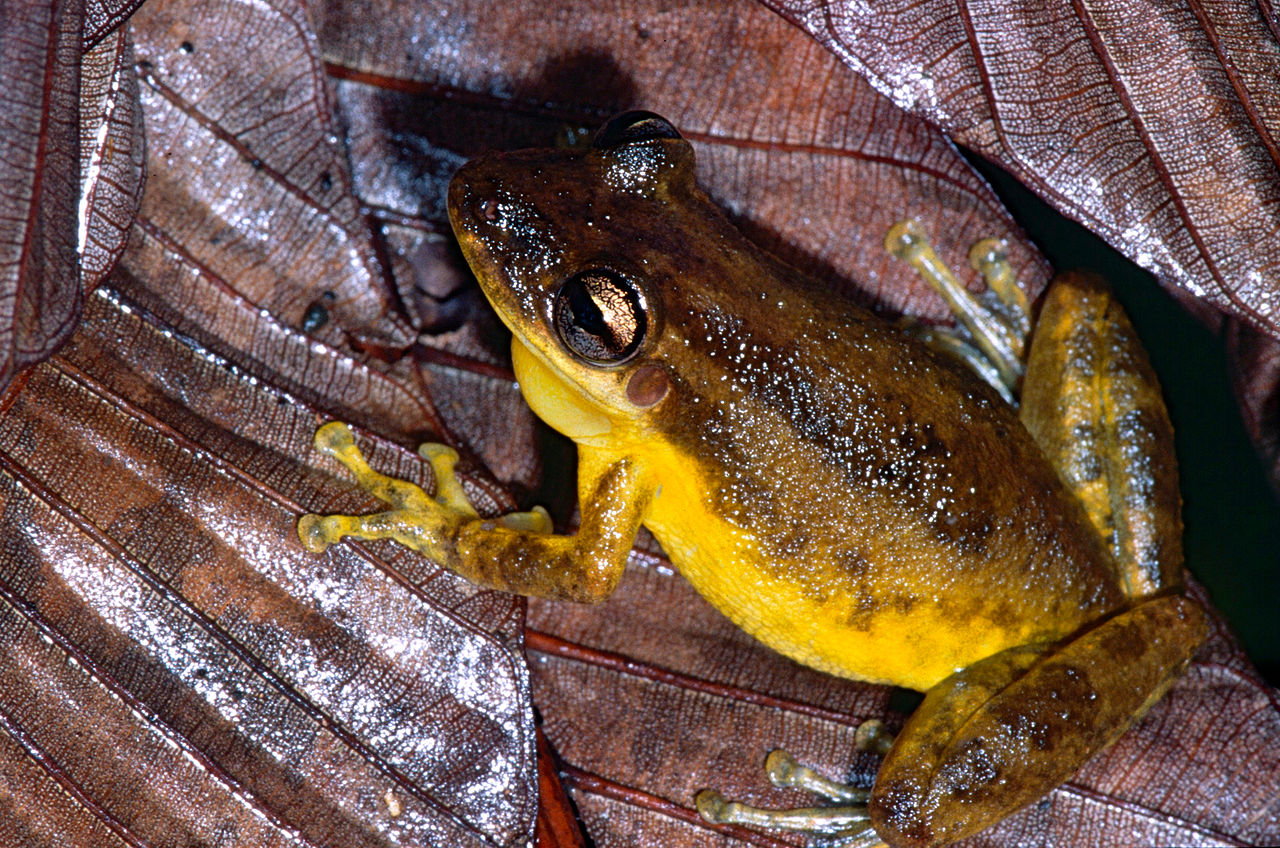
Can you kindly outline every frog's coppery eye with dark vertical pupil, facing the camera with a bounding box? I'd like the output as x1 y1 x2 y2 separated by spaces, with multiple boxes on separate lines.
554 268 648 365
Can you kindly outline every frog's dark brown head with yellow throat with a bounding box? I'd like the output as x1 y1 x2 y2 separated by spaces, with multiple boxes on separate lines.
449 111 710 443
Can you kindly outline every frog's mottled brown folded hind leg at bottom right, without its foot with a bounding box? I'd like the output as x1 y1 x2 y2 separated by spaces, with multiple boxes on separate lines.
869 596 1206 847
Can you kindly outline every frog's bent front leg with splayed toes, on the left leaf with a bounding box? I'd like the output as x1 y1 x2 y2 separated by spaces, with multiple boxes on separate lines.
298 423 653 603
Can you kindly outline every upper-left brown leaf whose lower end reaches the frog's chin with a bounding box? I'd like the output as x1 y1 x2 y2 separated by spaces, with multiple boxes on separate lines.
125 1 539 485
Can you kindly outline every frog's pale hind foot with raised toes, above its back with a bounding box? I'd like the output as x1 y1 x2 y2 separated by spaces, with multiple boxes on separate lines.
884 220 1030 405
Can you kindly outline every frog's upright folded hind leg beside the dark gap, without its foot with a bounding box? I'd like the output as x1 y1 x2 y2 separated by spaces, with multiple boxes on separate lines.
1019 273 1183 597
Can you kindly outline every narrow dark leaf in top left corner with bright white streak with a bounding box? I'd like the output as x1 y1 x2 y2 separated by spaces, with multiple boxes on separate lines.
0 1 142 399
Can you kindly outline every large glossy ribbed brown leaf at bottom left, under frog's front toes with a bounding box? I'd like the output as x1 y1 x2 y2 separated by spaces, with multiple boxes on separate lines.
0 286 536 847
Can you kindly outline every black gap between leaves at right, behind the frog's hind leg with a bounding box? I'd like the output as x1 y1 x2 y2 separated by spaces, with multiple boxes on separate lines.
966 151 1280 685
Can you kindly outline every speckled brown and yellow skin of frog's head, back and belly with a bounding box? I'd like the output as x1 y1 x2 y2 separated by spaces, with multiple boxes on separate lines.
449 134 1125 689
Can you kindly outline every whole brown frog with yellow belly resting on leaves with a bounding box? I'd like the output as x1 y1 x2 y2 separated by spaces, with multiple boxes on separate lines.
297 111 1207 848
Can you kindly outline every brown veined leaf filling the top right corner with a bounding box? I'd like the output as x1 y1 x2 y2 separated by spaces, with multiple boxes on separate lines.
767 0 1280 334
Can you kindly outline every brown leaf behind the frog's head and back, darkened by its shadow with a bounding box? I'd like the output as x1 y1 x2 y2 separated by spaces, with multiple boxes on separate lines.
319 1 1048 320
